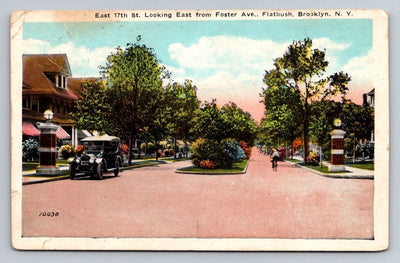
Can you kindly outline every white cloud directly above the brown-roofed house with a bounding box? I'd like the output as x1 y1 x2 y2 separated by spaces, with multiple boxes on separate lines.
23 39 114 77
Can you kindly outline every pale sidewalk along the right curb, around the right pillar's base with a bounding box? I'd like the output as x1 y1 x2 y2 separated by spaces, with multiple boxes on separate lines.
286 156 374 179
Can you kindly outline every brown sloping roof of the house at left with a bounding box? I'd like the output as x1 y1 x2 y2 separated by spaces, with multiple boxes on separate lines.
23 54 78 100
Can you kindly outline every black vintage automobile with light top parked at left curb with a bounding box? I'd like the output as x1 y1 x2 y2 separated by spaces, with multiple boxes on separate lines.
69 135 122 180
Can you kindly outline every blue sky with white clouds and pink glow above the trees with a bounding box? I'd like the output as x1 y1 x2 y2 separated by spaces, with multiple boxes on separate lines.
23 19 375 121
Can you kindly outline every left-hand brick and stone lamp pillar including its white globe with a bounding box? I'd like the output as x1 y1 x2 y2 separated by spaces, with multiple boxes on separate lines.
36 110 61 176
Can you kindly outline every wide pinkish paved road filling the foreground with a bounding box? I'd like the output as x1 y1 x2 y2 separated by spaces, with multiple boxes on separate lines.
22 150 374 239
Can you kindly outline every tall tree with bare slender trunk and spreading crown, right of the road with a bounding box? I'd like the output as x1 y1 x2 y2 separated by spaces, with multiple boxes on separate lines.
264 38 350 163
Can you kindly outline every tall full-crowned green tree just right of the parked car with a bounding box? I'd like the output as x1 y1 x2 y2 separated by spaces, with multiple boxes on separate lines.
100 39 162 163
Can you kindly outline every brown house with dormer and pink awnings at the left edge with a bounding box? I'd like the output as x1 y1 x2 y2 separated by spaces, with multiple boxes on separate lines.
22 54 78 144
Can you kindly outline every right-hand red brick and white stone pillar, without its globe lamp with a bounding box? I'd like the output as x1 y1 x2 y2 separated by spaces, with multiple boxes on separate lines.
328 129 346 172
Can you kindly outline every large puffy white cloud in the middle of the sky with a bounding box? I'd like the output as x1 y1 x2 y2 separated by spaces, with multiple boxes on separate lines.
168 36 288 73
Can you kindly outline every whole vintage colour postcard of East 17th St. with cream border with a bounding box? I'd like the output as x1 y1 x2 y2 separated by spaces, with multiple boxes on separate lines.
10 10 389 251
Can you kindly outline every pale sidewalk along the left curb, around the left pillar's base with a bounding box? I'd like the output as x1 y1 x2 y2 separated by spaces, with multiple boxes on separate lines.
22 159 175 185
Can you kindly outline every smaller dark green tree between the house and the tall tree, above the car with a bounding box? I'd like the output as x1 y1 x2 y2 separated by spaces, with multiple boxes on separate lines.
71 80 113 135
